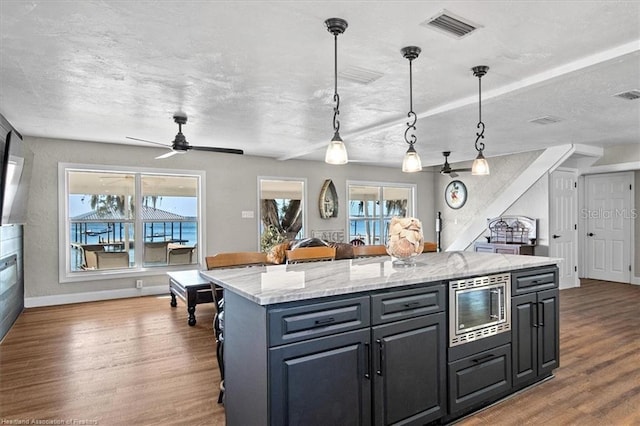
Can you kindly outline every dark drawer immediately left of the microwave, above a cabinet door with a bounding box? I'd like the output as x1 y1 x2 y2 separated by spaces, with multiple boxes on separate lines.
371 284 445 324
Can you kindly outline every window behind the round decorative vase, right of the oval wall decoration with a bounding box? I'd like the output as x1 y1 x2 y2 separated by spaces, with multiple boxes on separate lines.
347 182 416 244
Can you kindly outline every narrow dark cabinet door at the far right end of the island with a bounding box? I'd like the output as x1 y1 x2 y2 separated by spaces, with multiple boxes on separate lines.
538 290 560 376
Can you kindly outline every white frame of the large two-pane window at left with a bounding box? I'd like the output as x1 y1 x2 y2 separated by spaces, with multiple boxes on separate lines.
58 163 207 283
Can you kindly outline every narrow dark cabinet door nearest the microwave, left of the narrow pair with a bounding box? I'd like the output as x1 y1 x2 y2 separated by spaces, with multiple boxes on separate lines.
511 293 538 386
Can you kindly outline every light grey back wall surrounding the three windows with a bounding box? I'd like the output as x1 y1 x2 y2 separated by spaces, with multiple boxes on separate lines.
24 137 435 300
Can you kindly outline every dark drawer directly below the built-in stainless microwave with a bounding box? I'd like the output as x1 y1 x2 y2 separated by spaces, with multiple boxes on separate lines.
449 344 511 414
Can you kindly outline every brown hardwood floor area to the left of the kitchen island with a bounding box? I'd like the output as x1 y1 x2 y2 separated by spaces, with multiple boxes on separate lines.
0 296 225 425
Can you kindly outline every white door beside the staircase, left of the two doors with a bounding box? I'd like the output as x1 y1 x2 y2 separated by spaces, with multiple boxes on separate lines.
549 170 580 289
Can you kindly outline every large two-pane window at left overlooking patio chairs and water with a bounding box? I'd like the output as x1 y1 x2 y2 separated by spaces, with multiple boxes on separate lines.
60 165 204 281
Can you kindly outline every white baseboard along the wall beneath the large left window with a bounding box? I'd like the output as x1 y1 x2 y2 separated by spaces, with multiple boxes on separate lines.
24 285 169 308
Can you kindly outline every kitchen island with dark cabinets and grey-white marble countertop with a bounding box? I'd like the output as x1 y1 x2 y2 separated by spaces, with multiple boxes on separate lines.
201 252 559 425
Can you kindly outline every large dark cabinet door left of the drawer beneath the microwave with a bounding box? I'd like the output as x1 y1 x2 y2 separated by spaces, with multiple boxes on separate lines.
373 313 446 425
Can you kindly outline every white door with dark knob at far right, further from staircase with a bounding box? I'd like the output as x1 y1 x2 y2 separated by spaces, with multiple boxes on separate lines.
583 172 633 283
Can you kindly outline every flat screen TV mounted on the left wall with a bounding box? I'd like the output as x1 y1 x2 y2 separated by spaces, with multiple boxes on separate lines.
0 130 33 225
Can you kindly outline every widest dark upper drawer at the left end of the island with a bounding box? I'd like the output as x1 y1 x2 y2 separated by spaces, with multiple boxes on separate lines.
268 296 370 346
